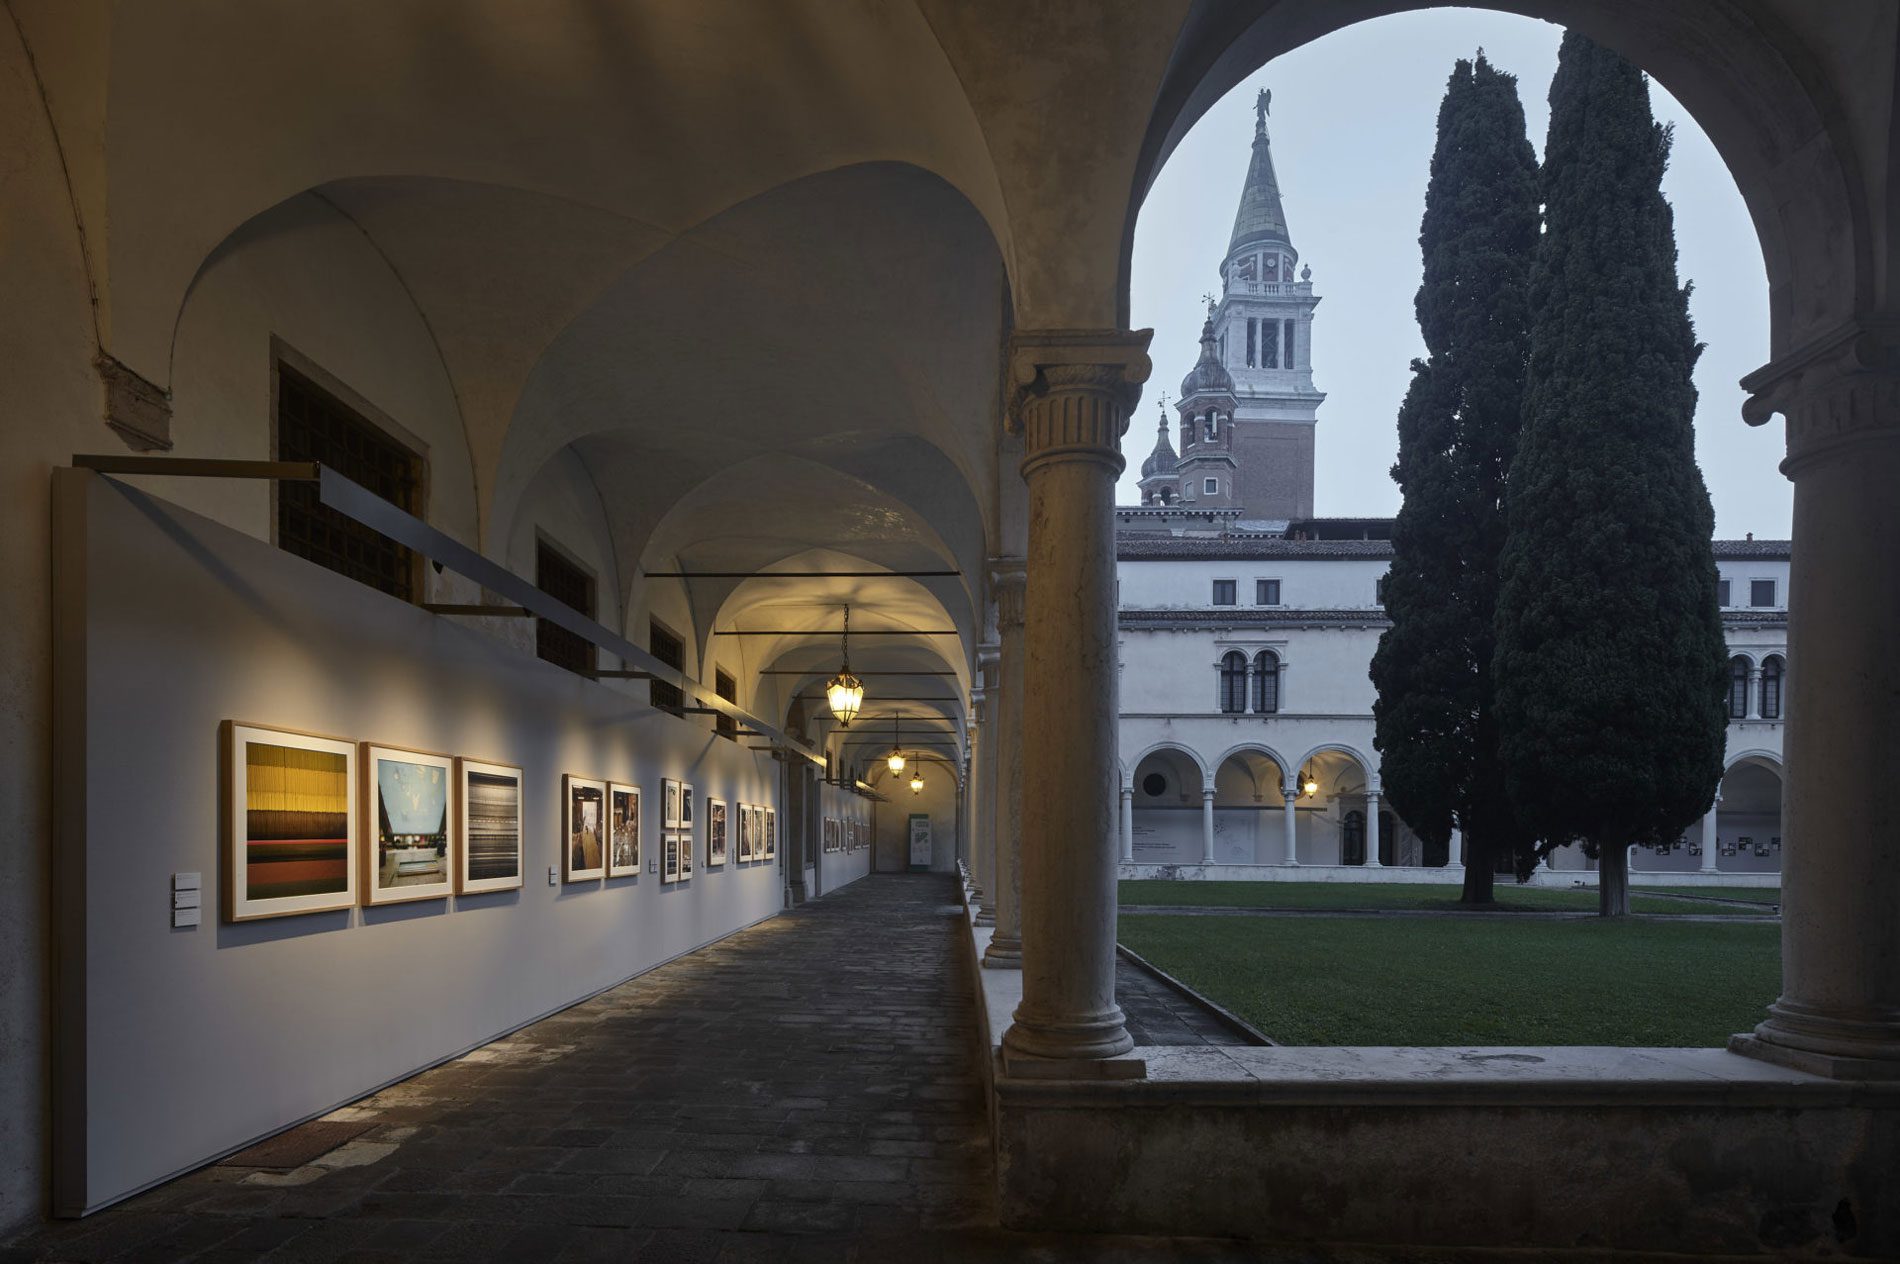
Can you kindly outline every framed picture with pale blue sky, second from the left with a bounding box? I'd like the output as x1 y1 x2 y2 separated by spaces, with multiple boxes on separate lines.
363 741 456 905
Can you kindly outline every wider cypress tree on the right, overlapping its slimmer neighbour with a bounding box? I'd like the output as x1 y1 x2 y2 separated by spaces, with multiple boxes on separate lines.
1495 32 1727 914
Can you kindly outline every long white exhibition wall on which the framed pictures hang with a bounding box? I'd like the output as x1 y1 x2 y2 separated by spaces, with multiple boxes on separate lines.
55 469 870 1213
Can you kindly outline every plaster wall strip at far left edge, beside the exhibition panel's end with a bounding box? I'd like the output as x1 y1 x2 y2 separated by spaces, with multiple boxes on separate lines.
0 21 100 1237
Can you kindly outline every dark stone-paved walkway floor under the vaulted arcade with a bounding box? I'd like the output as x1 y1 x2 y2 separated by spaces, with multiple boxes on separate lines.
0 874 1763 1264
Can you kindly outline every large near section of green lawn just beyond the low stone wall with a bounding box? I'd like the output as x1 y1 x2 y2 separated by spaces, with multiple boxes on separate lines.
1121 914 1780 1045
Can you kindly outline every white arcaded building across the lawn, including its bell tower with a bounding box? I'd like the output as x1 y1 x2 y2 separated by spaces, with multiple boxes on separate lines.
1117 93 1790 882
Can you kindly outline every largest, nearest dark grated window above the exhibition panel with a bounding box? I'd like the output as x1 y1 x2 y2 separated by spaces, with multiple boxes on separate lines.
277 365 422 601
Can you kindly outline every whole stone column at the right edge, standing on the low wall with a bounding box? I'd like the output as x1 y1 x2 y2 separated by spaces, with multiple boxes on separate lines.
1731 340 1900 1080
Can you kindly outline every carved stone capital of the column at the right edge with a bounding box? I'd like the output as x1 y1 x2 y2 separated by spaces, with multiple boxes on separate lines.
1742 317 1900 477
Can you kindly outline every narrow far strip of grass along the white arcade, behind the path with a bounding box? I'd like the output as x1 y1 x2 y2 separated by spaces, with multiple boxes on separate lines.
1121 878 1775 916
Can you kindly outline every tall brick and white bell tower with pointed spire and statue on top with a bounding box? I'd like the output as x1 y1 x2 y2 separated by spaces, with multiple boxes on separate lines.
1208 89 1326 525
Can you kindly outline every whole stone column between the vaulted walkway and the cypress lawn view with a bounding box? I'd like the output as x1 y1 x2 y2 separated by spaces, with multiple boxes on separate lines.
1003 331 1153 1059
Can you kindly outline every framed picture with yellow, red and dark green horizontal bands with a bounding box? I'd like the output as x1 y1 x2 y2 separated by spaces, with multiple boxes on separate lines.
220 720 357 922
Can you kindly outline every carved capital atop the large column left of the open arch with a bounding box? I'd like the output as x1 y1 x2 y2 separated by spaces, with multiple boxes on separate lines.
1005 329 1155 475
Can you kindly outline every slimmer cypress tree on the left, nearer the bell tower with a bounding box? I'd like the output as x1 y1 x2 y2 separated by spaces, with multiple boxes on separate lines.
1372 49 1537 905
